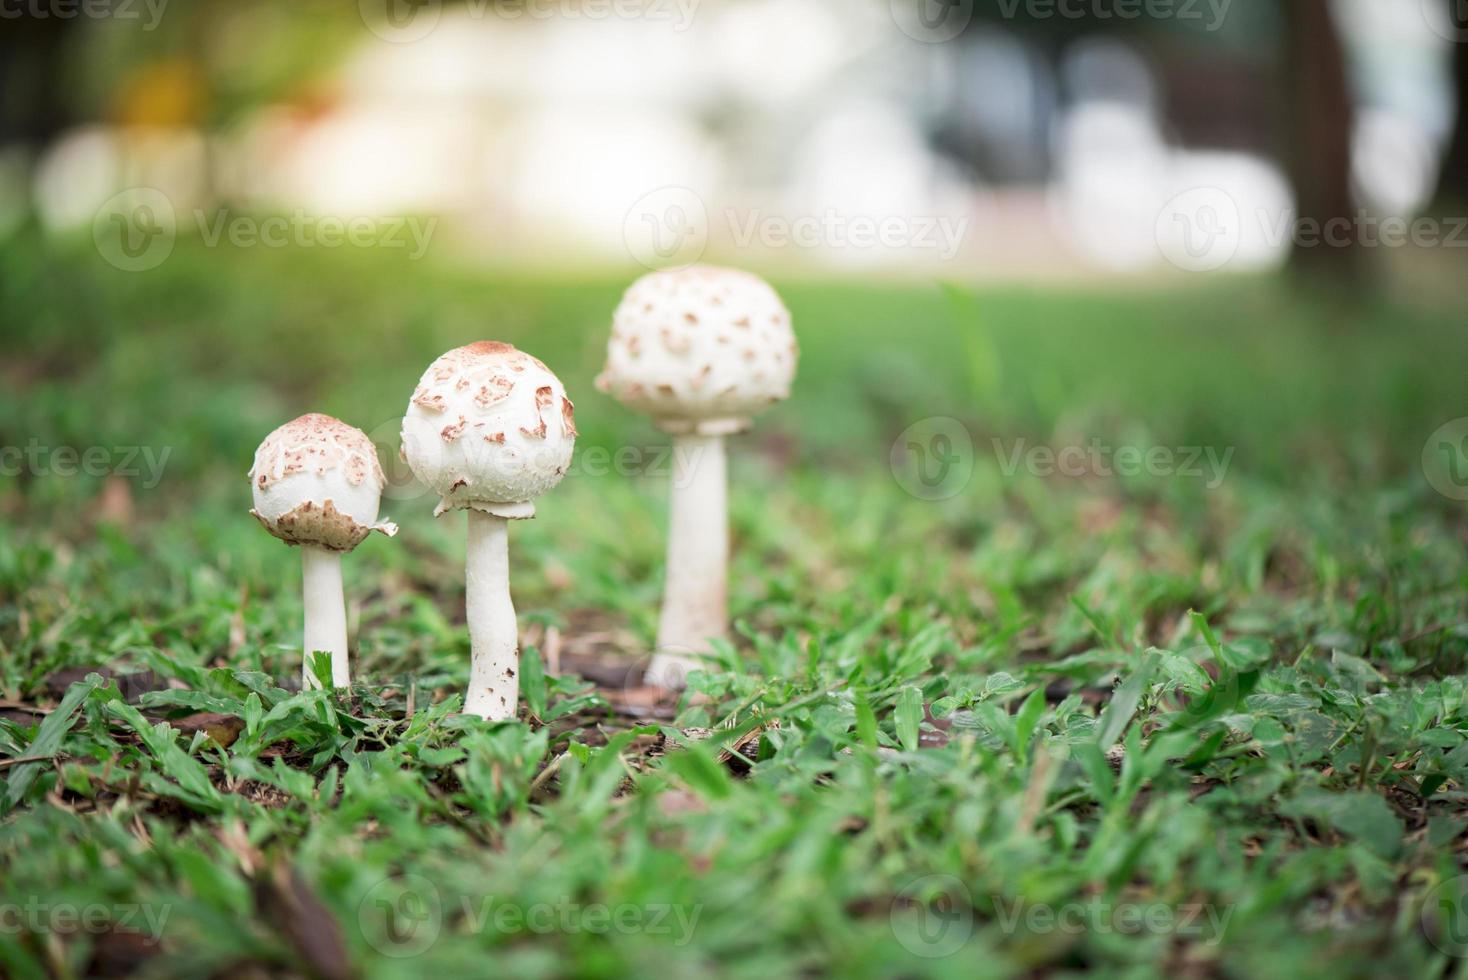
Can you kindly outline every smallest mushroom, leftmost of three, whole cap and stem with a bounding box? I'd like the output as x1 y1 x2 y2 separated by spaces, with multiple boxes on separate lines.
250 412 398 688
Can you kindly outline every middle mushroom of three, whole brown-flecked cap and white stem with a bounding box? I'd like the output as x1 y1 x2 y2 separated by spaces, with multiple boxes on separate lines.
402 340 575 720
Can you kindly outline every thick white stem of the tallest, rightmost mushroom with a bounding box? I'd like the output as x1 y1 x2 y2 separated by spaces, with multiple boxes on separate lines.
646 434 730 688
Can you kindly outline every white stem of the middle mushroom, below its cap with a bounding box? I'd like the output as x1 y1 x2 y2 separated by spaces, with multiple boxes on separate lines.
464 509 520 722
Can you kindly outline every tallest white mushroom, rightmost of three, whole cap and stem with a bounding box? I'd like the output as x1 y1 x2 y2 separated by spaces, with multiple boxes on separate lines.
596 266 799 688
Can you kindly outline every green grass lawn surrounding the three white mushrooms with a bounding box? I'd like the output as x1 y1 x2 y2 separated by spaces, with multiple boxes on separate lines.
0 233 1468 977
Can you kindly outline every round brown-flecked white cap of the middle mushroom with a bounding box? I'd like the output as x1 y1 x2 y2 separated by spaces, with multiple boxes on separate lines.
402 340 575 518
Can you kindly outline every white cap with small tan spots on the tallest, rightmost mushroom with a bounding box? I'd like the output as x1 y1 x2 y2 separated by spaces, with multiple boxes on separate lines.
596 266 800 436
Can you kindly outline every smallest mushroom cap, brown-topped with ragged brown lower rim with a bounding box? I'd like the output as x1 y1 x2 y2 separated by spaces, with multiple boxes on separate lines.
250 412 398 552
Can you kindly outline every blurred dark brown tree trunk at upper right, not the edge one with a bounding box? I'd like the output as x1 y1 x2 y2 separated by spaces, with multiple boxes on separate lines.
1282 0 1362 282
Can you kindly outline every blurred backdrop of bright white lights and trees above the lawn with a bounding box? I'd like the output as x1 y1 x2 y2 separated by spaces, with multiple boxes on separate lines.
0 0 1468 285
